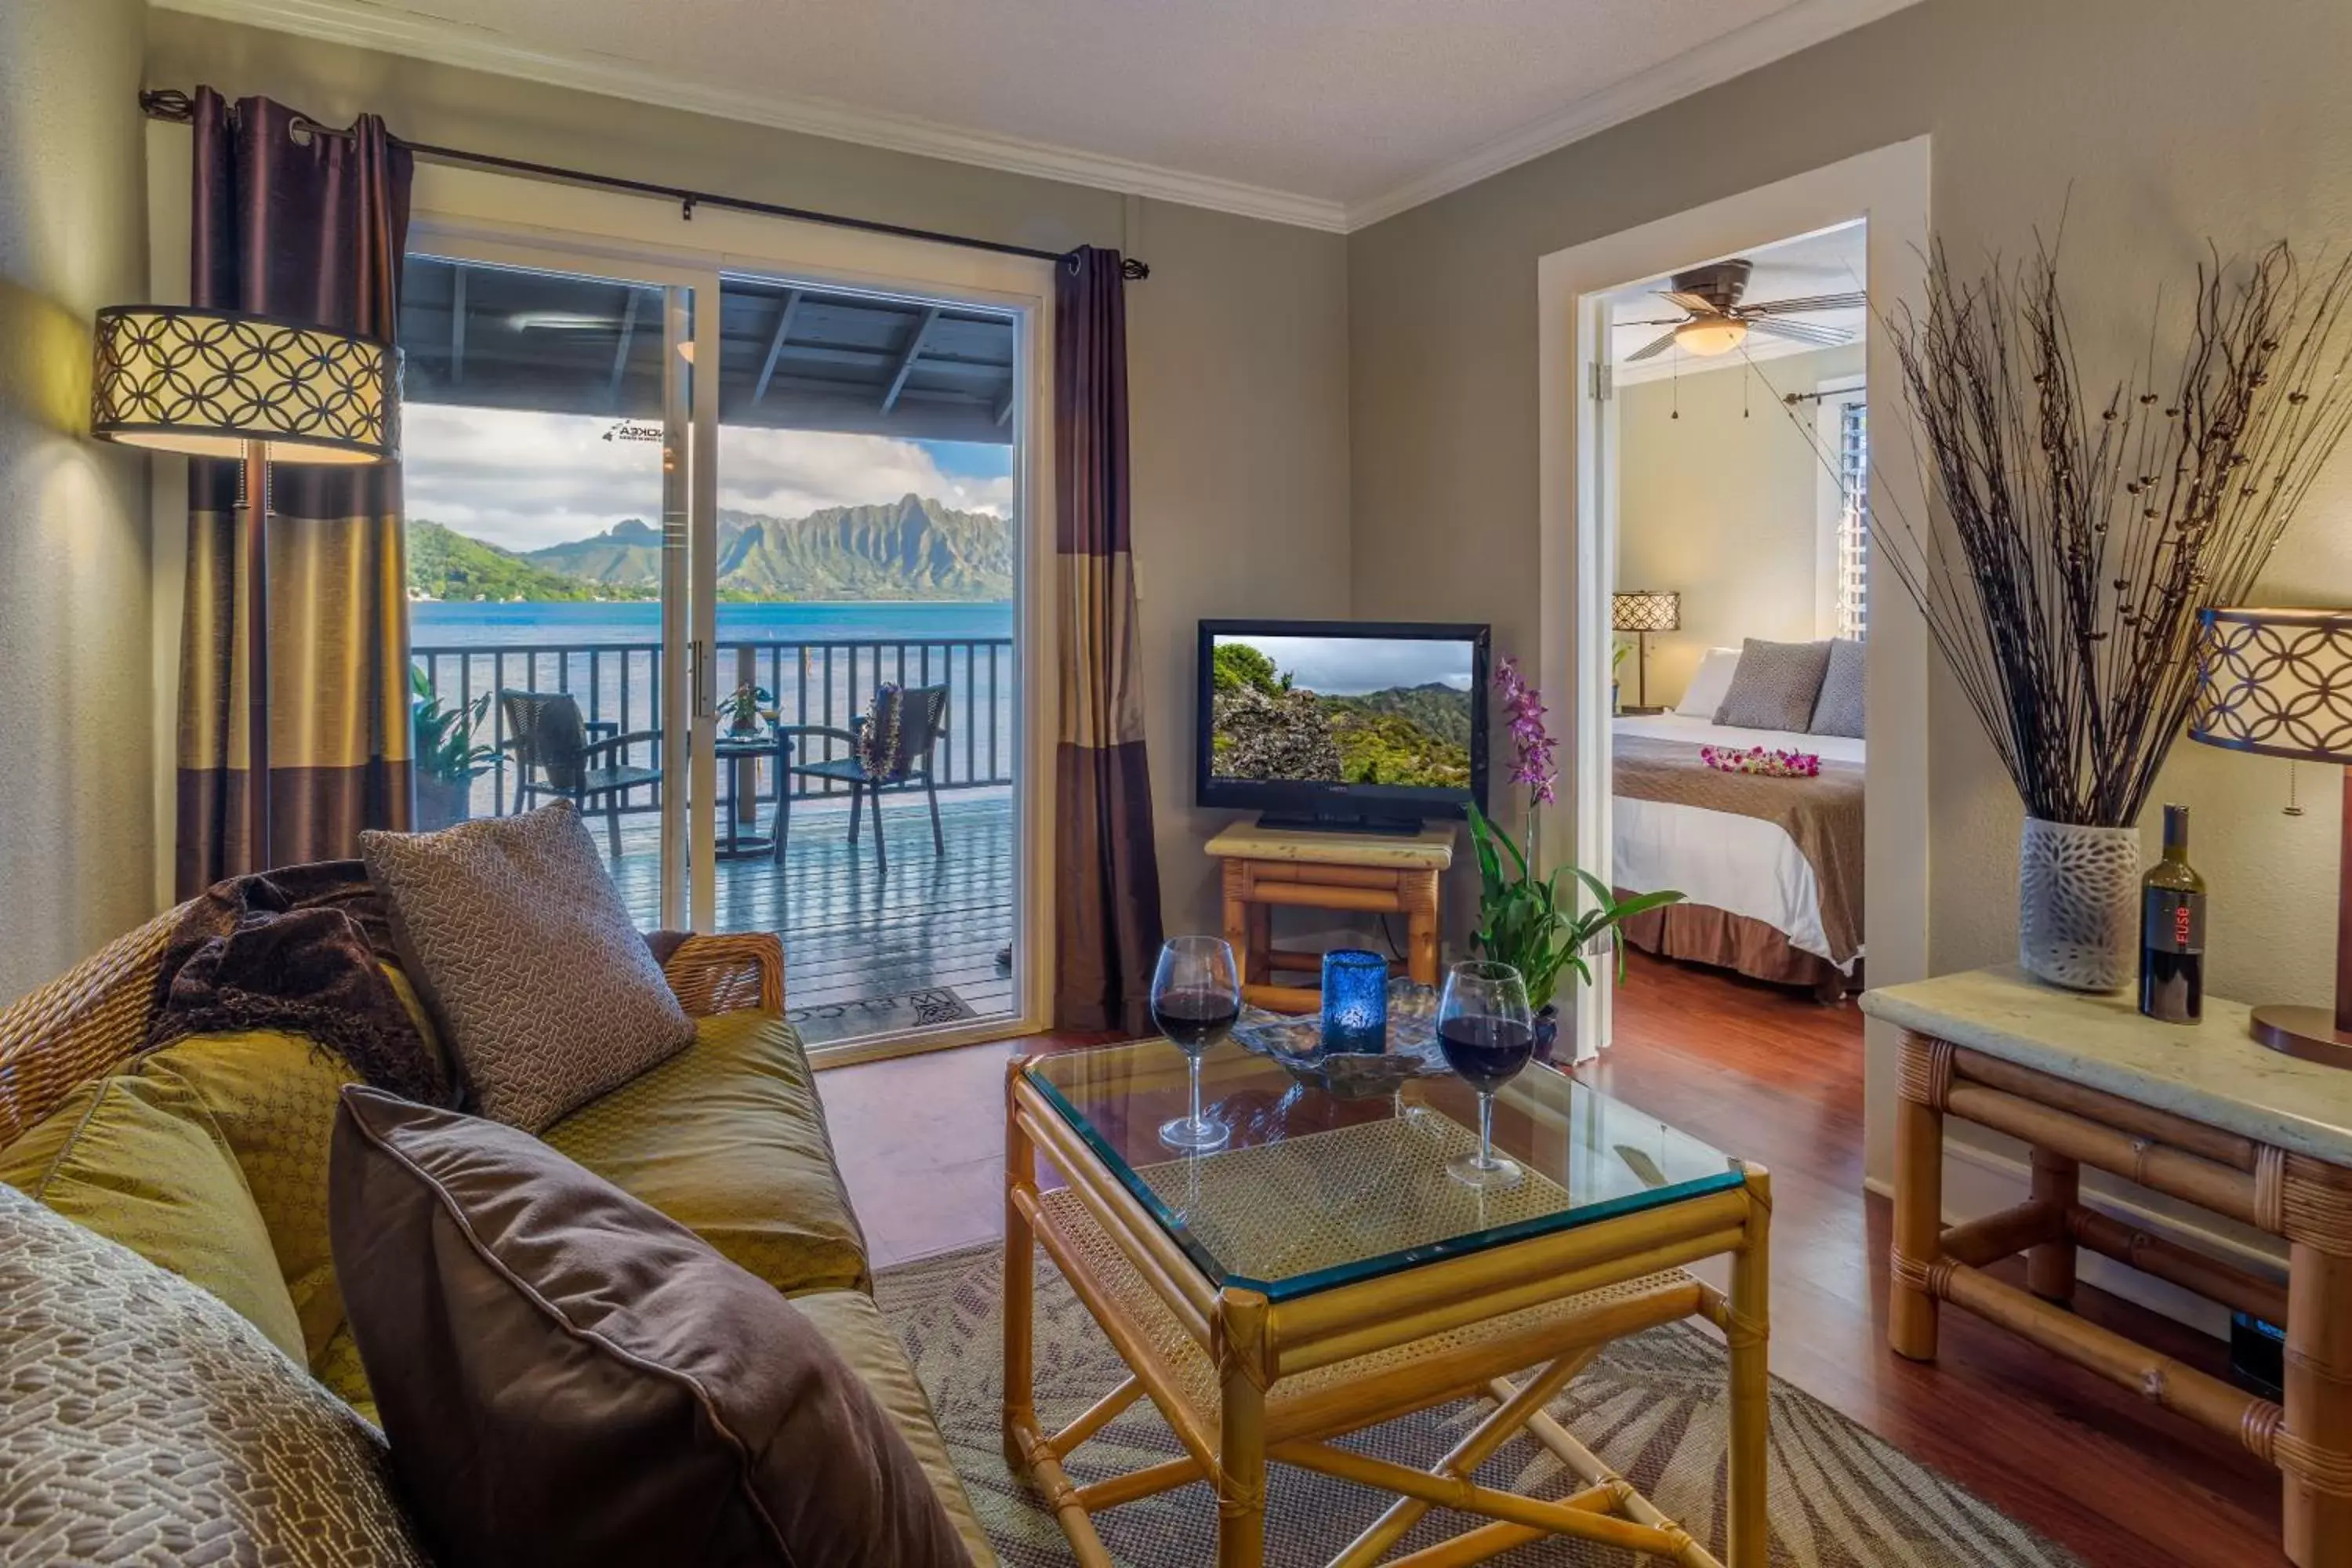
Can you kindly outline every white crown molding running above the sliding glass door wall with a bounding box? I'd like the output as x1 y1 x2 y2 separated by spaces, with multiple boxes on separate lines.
155 0 1348 233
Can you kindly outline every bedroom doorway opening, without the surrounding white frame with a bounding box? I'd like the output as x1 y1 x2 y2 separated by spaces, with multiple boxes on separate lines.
1595 221 1870 1029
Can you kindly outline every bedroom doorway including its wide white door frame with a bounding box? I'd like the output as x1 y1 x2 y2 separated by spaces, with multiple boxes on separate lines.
1538 139 1929 1142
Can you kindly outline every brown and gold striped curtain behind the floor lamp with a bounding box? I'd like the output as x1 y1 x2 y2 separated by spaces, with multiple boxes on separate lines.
176 87 412 898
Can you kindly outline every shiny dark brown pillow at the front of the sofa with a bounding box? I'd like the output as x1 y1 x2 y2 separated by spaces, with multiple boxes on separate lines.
329 1083 971 1568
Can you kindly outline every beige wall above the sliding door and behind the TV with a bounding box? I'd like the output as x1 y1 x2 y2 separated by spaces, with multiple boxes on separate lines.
146 12 1348 945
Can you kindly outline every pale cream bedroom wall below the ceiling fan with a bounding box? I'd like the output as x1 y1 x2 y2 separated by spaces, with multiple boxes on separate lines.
1616 346 1863 706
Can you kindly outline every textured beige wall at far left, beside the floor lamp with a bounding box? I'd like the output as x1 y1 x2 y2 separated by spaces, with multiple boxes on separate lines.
0 0 153 1001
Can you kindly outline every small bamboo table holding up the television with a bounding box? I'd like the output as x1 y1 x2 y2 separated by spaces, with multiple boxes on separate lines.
1209 822 1454 1013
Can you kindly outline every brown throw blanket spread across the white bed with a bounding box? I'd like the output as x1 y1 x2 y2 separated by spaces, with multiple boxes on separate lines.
1613 736 1863 964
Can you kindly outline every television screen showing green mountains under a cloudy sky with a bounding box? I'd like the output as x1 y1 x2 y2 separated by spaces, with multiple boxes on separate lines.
1209 637 1470 789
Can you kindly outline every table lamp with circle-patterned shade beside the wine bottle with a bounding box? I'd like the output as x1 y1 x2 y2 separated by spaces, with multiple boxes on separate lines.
2190 609 2352 1067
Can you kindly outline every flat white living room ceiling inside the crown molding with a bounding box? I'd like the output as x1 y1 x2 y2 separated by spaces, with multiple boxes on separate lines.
158 0 1912 230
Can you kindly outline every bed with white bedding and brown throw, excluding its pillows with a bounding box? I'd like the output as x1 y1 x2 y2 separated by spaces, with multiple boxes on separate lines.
1611 713 1865 999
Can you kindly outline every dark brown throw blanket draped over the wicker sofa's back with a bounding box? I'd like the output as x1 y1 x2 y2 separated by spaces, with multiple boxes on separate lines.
148 860 452 1105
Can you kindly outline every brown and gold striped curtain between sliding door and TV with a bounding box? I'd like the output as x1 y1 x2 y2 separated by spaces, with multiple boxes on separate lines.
1054 247 1160 1034
